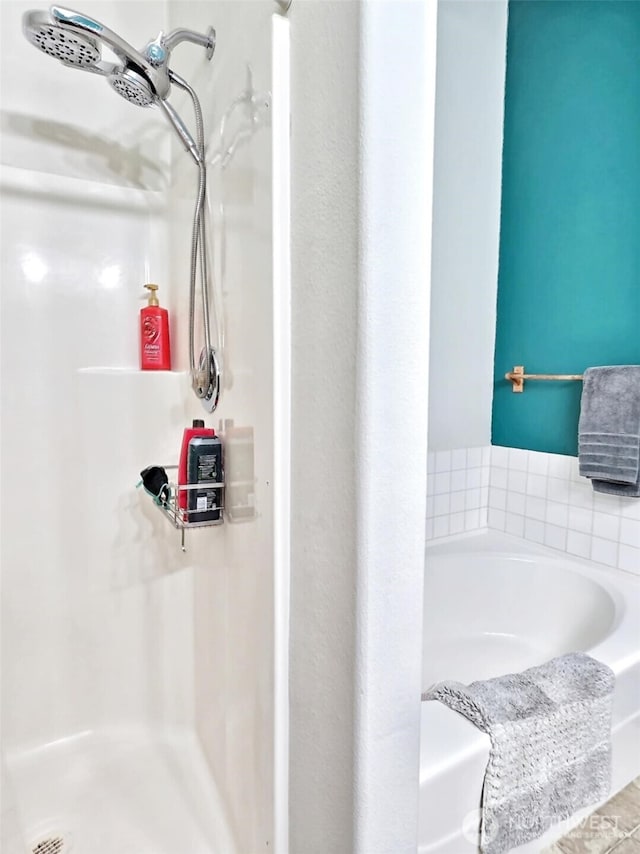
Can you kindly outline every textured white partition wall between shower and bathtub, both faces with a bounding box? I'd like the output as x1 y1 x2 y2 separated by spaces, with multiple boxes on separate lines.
290 2 435 854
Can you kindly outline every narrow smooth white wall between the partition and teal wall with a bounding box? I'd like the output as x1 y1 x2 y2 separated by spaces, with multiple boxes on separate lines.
429 0 507 451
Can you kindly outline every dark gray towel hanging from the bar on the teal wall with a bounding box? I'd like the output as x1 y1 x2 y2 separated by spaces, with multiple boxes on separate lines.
578 365 640 497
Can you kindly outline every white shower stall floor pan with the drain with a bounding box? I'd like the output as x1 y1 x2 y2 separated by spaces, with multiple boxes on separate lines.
7 729 235 854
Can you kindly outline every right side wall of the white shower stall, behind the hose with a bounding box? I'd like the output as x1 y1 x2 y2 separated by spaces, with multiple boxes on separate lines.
169 0 290 851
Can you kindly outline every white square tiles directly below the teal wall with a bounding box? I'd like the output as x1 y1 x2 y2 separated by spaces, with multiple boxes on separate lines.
488 446 640 575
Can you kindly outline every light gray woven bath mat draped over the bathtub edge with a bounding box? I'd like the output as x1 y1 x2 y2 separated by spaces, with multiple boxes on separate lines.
422 652 615 854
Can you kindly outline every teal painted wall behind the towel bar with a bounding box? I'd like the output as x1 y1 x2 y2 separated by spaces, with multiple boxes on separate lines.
496 0 640 455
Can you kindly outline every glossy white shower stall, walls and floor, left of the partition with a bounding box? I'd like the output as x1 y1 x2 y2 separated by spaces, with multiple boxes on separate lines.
0 0 286 854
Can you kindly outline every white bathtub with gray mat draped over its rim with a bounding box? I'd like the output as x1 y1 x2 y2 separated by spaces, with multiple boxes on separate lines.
419 531 640 854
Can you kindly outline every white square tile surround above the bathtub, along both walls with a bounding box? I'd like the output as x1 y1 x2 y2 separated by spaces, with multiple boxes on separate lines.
427 445 640 575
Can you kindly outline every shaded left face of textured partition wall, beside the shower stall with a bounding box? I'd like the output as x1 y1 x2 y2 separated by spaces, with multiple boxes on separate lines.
290 0 360 854
